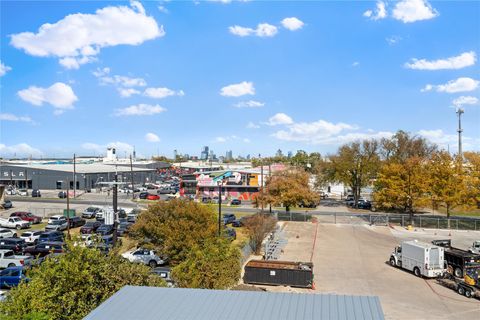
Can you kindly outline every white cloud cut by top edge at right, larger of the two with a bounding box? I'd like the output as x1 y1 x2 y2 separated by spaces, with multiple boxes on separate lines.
392 0 438 23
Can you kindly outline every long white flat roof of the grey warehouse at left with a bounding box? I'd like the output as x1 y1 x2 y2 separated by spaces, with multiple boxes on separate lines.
4 163 155 174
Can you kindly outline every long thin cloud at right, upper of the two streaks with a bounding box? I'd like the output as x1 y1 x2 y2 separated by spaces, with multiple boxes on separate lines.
405 51 477 70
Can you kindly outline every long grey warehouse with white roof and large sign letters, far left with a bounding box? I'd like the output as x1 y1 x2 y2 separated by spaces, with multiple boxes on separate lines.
0 162 170 190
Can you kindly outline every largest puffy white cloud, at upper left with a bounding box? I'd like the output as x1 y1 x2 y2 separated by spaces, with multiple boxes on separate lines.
11 1 165 69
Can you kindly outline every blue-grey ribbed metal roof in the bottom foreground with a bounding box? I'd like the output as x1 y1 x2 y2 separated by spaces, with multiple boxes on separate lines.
84 286 384 320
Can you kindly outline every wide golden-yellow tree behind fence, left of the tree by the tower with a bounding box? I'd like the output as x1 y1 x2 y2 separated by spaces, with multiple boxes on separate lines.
374 157 428 221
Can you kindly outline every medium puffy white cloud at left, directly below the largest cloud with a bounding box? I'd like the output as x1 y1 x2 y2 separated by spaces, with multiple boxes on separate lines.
18 82 78 114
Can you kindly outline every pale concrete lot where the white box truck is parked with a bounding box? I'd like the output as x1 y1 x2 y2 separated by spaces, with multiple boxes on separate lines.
274 222 480 319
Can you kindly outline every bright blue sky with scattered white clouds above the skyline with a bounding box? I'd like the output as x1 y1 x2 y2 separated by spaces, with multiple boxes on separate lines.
0 0 480 157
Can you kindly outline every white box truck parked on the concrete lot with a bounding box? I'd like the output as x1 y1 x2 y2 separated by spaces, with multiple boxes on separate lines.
390 240 446 278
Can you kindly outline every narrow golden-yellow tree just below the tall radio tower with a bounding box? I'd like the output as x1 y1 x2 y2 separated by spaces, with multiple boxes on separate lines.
427 151 468 218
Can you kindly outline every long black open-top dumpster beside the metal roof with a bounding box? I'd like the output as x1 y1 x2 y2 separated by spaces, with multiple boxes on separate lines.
243 260 313 288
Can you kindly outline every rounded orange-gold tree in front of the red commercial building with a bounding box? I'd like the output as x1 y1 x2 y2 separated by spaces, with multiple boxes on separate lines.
254 169 318 212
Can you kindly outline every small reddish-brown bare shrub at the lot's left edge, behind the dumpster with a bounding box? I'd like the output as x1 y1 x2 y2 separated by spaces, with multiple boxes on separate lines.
243 214 277 254
